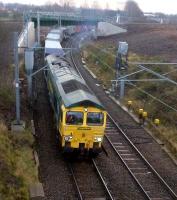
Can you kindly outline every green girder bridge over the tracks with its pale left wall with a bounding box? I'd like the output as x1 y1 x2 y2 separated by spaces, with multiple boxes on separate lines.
18 12 115 52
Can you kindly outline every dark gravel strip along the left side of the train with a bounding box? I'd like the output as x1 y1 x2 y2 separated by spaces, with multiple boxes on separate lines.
33 49 77 200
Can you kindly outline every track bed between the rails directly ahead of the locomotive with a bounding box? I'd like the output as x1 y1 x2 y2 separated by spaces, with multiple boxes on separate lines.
68 159 114 200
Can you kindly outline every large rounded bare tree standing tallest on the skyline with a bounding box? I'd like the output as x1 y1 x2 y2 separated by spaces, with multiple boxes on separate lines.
124 0 143 17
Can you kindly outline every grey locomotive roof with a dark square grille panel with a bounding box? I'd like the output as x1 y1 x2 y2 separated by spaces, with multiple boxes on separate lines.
46 55 104 109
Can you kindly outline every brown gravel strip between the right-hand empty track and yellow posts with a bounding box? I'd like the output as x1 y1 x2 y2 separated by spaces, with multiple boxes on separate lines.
69 32 177 198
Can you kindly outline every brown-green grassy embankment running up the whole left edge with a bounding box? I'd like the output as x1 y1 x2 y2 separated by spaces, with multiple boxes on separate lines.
0 21 38 200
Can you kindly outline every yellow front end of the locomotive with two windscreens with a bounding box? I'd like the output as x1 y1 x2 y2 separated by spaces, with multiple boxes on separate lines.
59 106 106 153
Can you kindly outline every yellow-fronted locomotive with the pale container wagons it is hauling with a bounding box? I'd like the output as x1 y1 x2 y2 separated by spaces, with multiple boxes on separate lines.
45 26 107 155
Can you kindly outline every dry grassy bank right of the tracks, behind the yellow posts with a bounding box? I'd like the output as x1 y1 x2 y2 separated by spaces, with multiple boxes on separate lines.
84 42 177 157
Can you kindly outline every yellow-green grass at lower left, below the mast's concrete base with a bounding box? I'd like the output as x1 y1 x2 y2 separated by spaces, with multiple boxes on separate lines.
0 123 38 200
